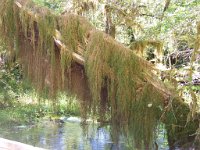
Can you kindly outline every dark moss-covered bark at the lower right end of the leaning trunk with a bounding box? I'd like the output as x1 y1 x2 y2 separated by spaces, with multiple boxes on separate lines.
162 98 199 149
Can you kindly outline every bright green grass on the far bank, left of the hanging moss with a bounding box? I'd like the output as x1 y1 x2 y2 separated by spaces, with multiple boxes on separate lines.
0 90 80 126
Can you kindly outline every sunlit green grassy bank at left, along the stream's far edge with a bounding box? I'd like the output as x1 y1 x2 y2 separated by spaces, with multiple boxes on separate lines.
0 95 80 126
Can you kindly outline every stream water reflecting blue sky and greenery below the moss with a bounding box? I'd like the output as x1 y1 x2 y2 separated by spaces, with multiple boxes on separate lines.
0 119 169 150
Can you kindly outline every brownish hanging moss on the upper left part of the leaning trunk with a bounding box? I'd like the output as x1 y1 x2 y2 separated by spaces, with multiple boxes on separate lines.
1 0 87 96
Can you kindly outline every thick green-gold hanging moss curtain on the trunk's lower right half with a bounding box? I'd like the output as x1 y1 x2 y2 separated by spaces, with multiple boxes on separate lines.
86 31 168 148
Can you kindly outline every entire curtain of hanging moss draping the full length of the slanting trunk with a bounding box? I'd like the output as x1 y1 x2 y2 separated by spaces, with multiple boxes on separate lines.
0 0 198 149
